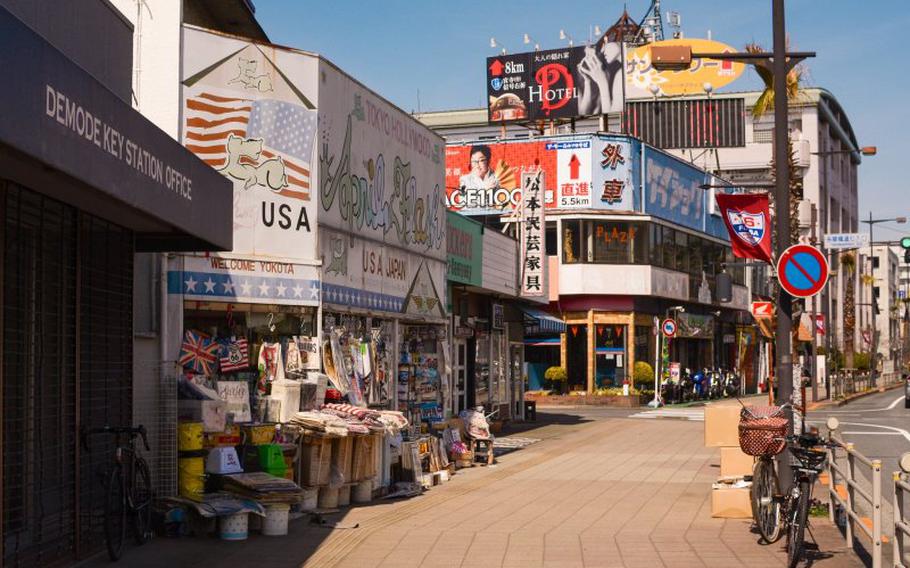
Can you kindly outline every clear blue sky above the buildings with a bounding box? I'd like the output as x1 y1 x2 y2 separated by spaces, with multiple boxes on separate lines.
253 0 910 240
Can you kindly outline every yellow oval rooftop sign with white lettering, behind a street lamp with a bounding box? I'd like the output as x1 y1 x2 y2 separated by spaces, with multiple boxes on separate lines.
626 39 746 98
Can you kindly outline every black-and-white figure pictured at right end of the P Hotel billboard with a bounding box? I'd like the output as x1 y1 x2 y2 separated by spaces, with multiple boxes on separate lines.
575 41 623 116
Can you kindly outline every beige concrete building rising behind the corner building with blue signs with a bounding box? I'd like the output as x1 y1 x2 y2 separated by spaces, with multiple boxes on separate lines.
417 88 861 364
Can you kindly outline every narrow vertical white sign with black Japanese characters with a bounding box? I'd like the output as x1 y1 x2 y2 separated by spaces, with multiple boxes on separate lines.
521 171 547 297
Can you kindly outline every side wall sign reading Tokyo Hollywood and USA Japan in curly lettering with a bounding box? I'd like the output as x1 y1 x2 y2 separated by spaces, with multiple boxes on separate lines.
318 59 447 318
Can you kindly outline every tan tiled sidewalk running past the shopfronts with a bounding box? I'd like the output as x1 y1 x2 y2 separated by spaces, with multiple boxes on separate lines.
76 412 862 568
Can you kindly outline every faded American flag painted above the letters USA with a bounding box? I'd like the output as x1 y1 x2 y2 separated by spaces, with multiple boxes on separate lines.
184 91 316 200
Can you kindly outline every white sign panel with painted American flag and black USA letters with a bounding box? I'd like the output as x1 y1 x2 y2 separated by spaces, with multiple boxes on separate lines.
181 27 318 261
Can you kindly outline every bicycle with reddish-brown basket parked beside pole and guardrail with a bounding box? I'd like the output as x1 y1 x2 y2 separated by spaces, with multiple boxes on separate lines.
740 404 837 568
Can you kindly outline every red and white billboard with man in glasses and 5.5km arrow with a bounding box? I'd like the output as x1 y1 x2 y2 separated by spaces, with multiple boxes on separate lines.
446 135 640 215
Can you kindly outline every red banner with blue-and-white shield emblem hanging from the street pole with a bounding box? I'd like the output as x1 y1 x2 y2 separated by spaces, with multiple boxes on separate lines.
715 193 772 264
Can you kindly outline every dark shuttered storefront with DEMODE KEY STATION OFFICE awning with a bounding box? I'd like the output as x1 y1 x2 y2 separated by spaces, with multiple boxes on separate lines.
0 4 232 566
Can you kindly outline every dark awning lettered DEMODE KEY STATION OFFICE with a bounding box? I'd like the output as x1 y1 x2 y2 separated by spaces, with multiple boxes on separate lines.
0 8 233 251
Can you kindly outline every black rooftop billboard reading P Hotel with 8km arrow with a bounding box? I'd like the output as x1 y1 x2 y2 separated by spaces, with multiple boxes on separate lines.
486 42 624 124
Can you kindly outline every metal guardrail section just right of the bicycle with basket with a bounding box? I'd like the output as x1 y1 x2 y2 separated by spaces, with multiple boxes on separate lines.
826 437 884 568
